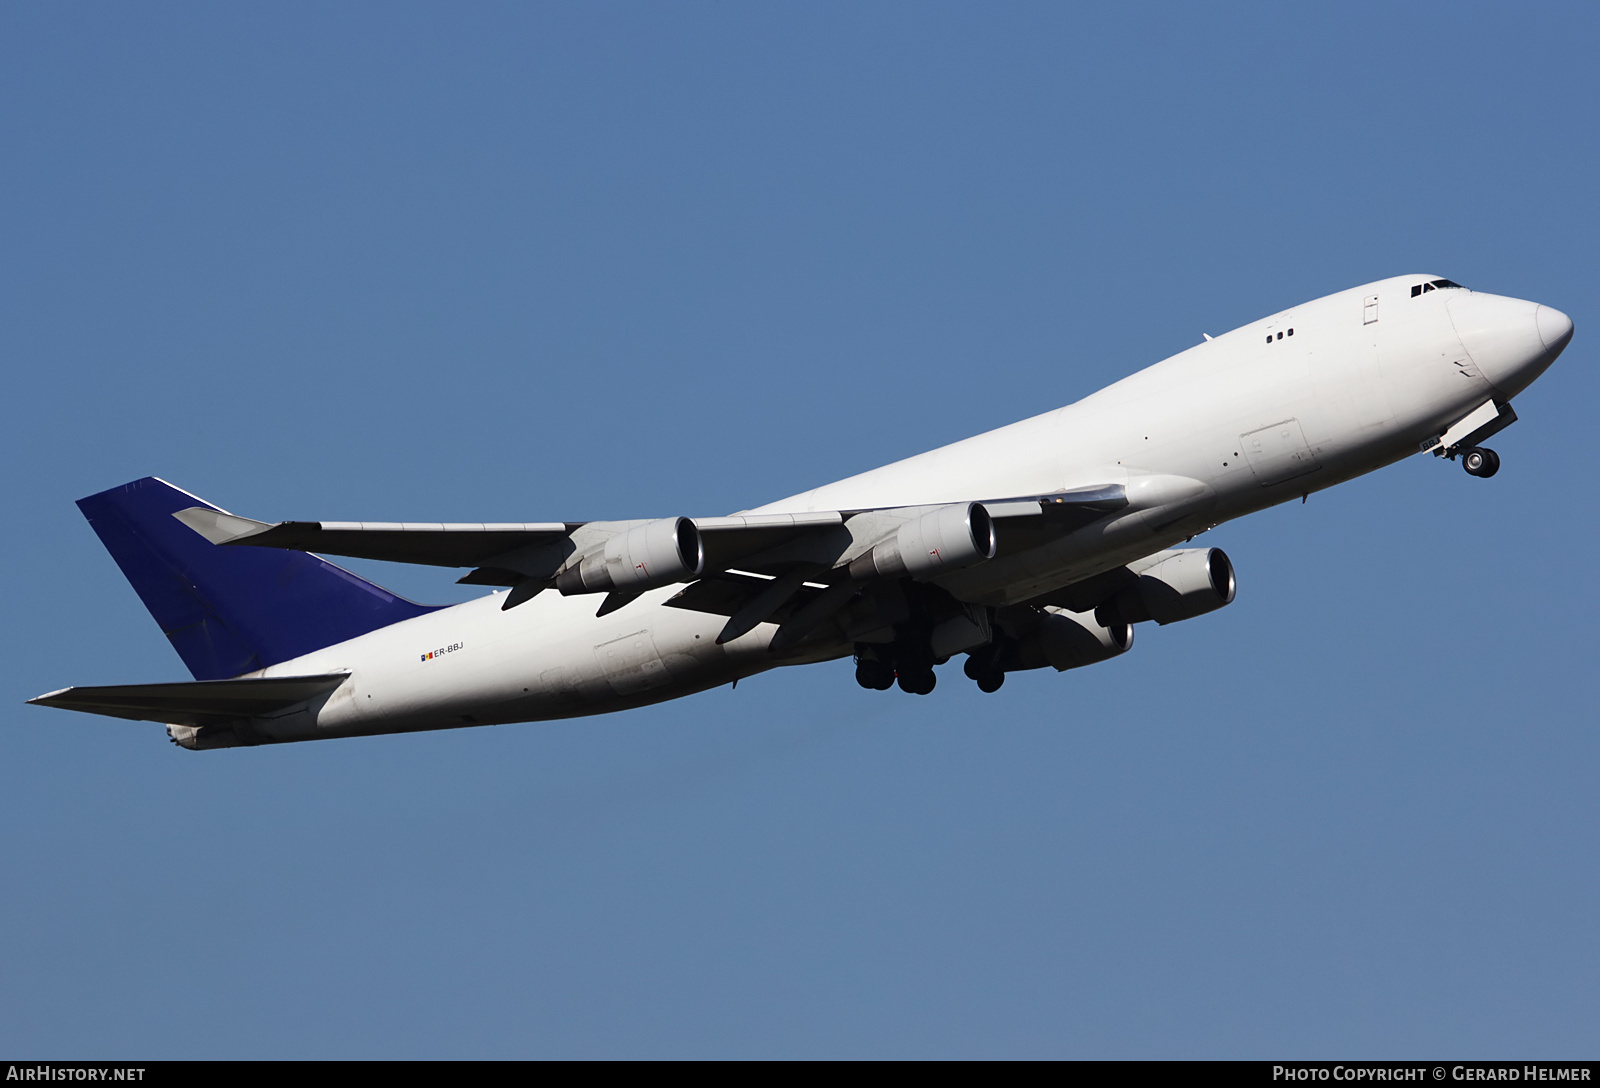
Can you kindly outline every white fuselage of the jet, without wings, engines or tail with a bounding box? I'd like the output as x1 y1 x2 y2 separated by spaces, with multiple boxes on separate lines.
225 277 1571 739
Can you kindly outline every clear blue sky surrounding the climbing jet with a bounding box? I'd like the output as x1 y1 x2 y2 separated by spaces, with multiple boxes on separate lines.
0 3 1600 1058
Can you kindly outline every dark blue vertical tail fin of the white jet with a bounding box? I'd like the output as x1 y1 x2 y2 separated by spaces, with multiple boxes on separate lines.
78 477 435 680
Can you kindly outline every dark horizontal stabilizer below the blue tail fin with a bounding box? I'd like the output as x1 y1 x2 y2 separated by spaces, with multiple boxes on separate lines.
29 672 347 725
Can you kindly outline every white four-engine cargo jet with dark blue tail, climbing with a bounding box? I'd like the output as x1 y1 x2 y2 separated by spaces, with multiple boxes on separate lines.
29 275 1573 749
